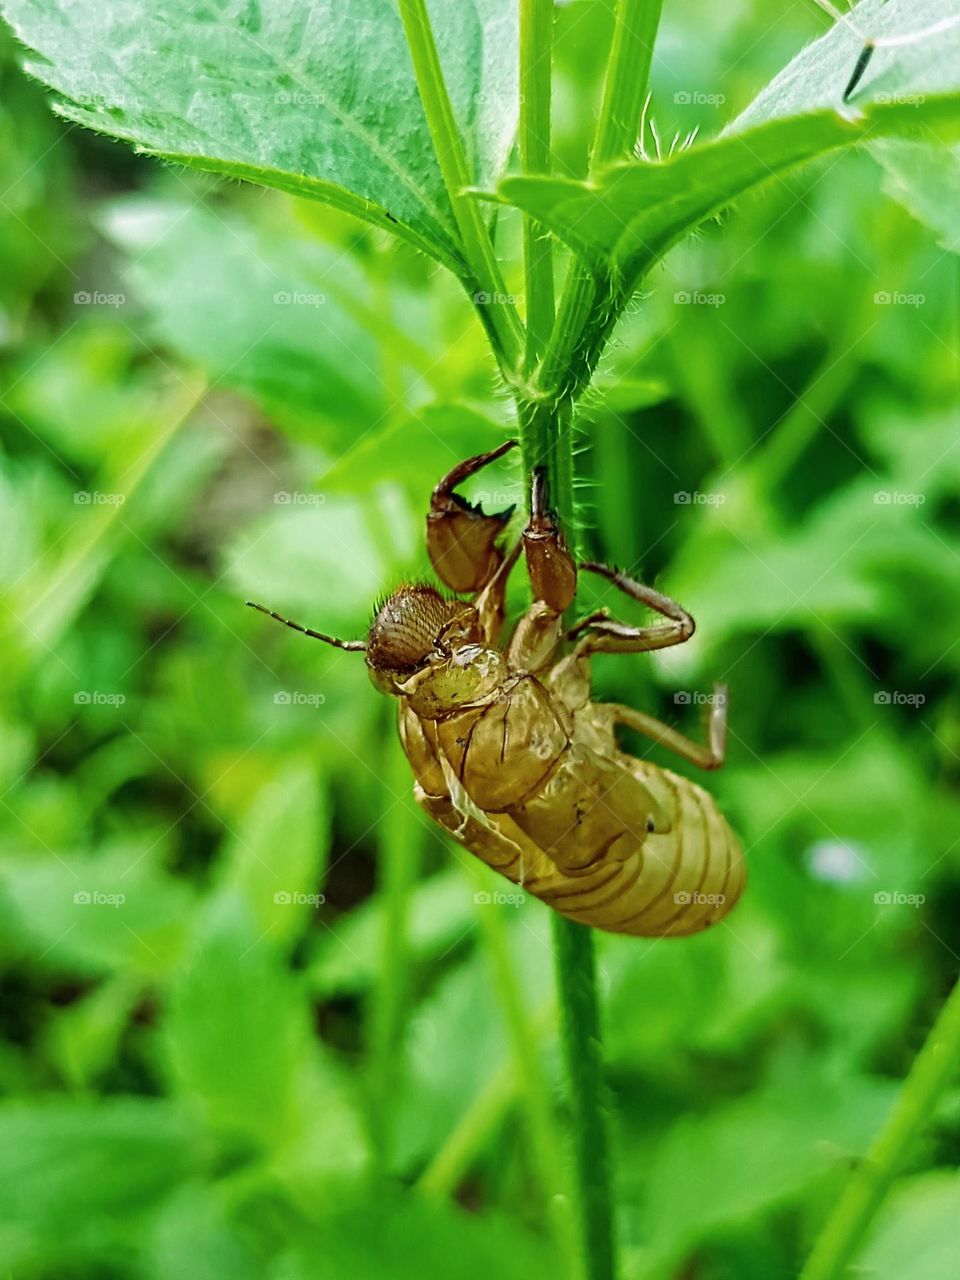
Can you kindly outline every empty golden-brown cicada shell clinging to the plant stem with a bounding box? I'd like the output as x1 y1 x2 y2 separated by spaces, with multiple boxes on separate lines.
245 440 745 937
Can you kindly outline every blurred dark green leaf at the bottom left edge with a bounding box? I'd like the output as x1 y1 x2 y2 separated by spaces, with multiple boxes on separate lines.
0 1098 200 1274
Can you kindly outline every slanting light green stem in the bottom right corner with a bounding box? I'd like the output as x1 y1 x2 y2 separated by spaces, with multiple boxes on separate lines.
800 967 960 1280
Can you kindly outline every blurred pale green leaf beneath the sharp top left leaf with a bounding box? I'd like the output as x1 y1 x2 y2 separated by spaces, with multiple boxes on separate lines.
105 198 383 438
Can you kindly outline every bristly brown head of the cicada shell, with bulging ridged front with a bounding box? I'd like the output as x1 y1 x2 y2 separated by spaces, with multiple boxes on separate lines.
366 585 506 718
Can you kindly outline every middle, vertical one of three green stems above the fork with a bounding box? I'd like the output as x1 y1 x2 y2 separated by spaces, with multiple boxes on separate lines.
520 0 554 371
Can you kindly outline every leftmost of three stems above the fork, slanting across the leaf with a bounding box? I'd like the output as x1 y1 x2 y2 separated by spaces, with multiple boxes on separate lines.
399 0 524 369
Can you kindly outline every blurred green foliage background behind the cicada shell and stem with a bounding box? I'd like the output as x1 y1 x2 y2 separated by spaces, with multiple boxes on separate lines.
0 0 960 1280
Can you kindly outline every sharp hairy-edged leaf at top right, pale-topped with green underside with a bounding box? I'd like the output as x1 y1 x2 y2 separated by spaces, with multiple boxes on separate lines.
499 0 960 292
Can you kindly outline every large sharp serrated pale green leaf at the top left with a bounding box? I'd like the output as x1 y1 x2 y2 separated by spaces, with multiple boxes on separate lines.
4 0 517 275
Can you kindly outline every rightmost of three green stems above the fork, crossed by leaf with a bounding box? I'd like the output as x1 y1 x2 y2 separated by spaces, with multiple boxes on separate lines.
540 0 663 398
